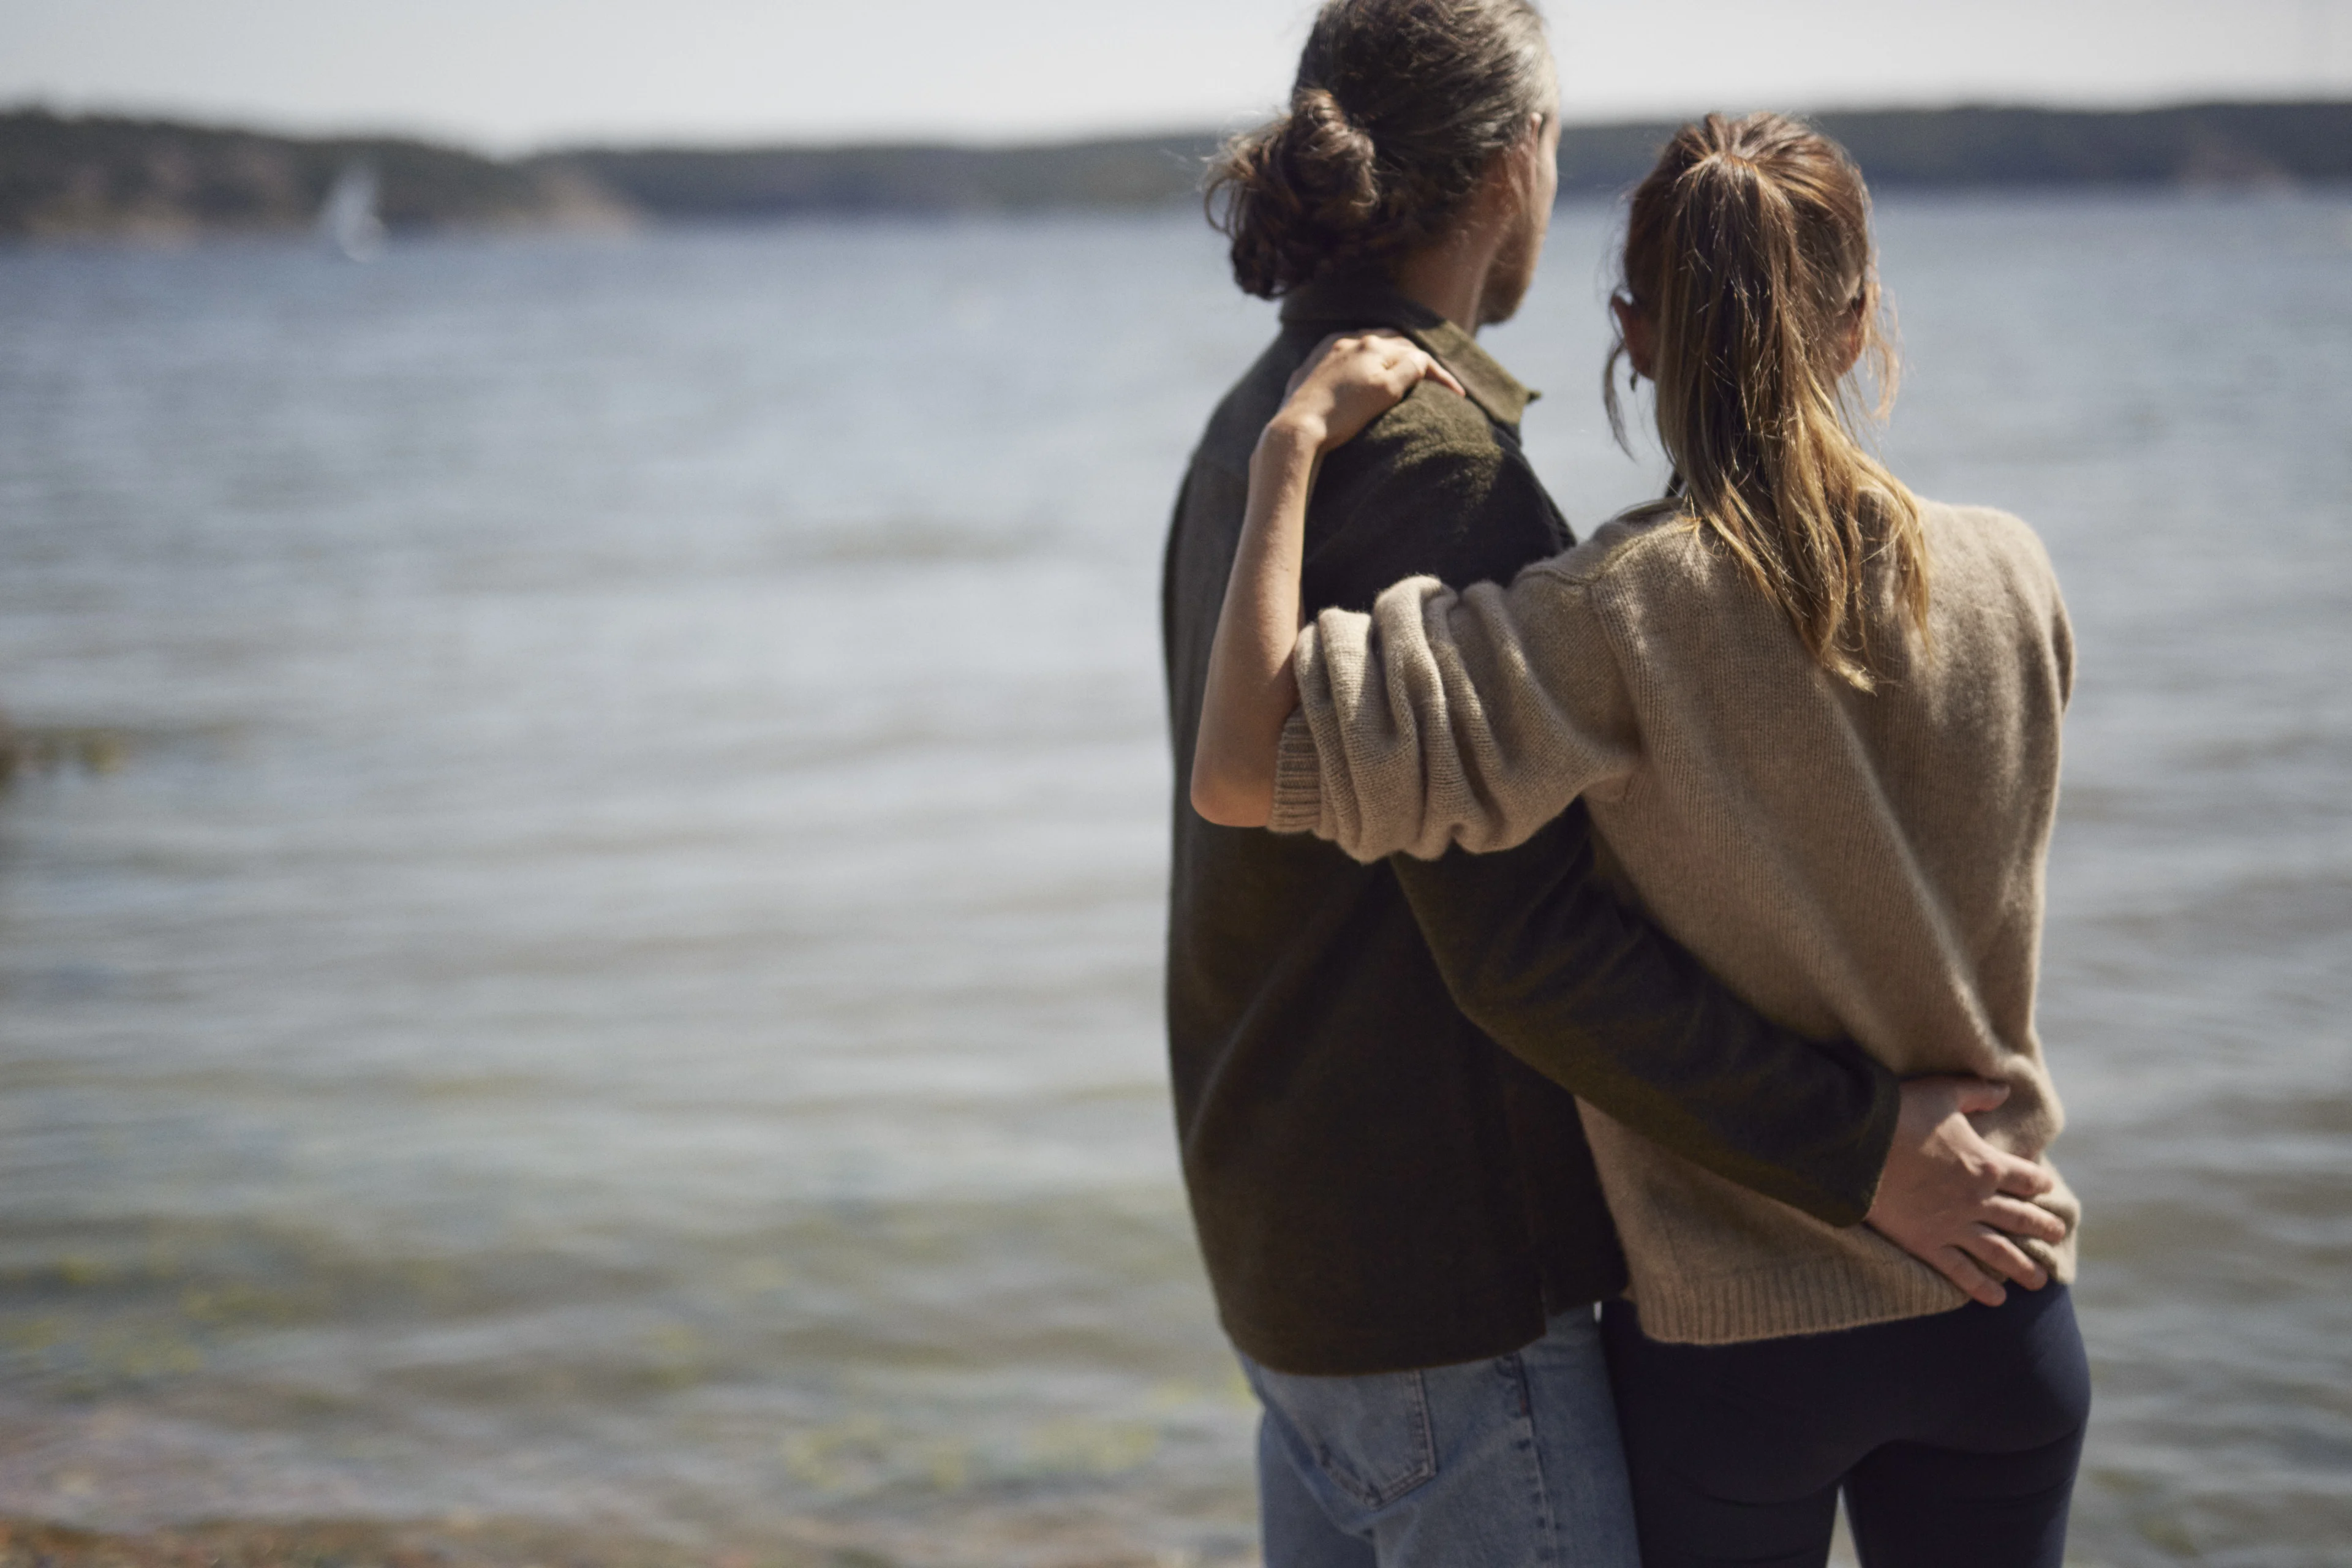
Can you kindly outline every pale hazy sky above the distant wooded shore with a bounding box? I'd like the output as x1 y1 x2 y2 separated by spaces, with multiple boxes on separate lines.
0 0 2352 151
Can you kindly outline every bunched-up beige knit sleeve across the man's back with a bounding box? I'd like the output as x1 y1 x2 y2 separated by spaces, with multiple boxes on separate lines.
1268 564 1639 861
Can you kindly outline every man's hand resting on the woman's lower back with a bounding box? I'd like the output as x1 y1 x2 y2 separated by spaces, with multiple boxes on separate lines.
1865 1077 2065 1307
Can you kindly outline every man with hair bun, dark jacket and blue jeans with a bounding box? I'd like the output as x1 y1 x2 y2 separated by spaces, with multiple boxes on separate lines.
1162 0 2039 1568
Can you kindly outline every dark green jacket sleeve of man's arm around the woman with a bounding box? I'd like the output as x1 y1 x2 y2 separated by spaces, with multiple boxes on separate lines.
1308 390 1901 1225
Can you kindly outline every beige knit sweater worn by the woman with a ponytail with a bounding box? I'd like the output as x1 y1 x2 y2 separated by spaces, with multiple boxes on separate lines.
1272 503 2079 1344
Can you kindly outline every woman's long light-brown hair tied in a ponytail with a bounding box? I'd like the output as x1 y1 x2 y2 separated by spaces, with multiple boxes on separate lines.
1602 115 1929 691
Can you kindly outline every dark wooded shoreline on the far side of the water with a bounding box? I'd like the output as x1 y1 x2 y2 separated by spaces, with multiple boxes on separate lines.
0 99 2352 239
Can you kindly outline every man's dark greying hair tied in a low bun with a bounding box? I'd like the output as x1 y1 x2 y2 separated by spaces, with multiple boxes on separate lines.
1207 0 1557 298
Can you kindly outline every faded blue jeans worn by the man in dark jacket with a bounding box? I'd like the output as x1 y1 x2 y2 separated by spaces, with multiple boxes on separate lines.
1242 1307 1637 1568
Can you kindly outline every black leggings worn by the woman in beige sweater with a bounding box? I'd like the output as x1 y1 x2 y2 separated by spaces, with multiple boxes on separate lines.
1602 1286 2091 1568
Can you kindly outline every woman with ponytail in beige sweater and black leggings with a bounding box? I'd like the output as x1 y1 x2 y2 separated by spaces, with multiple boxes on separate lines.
1193 115 2089 1568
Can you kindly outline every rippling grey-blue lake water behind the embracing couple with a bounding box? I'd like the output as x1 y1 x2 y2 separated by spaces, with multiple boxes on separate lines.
0 195 2352 1568
